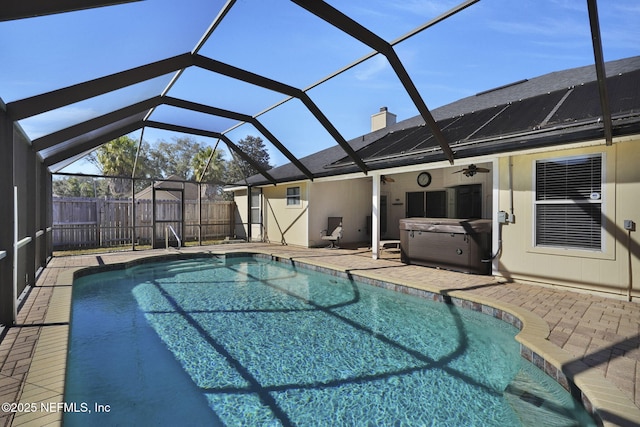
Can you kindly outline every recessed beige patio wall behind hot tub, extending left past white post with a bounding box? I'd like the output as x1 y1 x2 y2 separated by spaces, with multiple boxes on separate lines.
234 164 492 247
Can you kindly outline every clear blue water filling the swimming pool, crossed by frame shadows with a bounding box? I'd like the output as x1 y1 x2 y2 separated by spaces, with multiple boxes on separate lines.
64 257 592 426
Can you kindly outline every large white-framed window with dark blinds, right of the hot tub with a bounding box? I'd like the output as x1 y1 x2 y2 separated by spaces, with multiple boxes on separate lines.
534 153 604 251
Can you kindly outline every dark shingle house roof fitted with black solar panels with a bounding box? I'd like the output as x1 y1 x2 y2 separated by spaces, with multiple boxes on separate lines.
248 56 640 185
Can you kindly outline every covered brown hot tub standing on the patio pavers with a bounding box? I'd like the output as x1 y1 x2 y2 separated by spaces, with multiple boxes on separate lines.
400 218 491 274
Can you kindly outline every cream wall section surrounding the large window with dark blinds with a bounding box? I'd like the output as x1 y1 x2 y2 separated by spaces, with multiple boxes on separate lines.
496 139 640 295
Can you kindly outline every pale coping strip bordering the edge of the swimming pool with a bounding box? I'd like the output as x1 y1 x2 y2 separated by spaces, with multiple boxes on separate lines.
13 248 640 426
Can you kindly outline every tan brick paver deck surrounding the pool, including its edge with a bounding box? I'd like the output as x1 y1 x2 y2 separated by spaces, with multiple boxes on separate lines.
0 243 640 426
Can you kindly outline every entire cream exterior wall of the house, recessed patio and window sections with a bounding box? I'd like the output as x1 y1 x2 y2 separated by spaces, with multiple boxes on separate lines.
236 137 640 296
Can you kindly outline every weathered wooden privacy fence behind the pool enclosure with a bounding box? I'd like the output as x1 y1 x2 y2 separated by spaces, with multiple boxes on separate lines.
53 197 235 249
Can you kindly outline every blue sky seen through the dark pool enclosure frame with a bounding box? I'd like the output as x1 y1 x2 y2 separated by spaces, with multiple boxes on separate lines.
0 0 640 172
